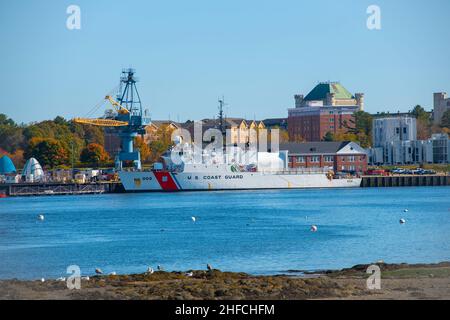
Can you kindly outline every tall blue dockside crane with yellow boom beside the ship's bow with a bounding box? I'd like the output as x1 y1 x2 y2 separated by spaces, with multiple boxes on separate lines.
74 68 151 170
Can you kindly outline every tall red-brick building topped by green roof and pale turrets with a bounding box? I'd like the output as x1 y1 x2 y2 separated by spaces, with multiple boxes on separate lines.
288 82 364 141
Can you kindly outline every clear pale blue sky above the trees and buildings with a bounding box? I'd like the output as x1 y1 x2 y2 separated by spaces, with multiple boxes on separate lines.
0 0 450 122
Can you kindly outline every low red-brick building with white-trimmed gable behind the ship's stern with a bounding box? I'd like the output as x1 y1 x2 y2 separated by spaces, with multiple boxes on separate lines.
280 141 368 174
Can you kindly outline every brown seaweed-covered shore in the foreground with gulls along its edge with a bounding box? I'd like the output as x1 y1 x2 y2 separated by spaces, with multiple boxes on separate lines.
0 262 450 300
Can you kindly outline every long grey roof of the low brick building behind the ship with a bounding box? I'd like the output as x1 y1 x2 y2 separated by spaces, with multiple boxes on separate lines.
280 141 351 154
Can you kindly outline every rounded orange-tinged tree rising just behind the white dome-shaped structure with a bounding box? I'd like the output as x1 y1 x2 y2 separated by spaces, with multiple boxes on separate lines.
25 138 68 168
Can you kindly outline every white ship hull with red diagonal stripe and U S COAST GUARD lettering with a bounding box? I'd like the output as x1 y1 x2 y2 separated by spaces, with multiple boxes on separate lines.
119 171 361 192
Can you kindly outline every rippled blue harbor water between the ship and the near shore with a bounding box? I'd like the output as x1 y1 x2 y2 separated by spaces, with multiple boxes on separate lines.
0 187 450 279
